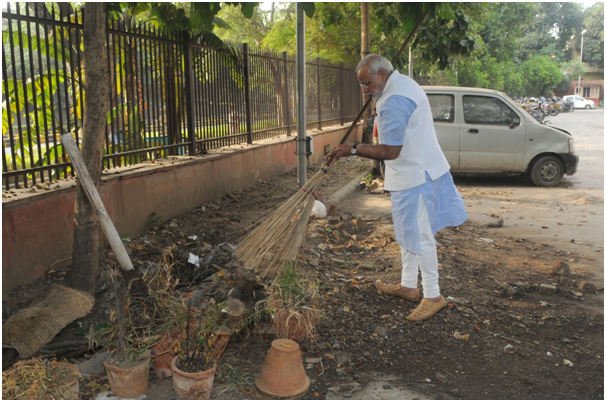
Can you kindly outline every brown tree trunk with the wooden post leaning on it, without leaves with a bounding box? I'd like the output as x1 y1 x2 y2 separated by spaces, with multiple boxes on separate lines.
72 3 109 291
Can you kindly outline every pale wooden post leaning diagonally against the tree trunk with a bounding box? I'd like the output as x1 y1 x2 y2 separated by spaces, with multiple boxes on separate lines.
61 133 134 271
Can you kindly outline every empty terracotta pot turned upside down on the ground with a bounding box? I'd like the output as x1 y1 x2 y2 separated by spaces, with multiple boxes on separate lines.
255 339 310 398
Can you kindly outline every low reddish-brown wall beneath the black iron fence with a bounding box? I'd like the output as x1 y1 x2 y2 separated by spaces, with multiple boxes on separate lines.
2 125 362 297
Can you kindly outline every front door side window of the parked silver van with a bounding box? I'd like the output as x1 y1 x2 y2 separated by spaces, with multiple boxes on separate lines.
463 95 520 127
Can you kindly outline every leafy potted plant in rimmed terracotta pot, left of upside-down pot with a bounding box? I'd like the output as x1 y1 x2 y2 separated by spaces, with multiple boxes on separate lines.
171 301 229 399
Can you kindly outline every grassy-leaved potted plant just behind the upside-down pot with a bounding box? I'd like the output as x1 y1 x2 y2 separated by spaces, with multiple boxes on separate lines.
267 261 320 340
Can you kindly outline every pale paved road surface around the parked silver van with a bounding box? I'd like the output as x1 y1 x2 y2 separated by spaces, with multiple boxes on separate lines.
339 109 604 287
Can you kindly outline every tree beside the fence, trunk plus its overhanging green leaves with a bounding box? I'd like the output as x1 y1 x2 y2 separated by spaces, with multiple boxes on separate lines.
72 3 257 290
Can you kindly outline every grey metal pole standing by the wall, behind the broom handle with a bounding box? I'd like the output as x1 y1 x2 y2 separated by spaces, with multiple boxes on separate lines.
297 3 307 187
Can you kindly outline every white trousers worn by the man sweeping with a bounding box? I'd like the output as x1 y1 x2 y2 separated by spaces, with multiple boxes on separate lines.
401 195 440 298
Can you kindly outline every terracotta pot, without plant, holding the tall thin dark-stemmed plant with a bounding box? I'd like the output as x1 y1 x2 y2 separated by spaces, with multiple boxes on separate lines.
103 353 151 398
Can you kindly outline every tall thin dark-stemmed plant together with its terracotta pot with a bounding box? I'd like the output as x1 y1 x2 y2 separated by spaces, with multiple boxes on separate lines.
103 270 154 398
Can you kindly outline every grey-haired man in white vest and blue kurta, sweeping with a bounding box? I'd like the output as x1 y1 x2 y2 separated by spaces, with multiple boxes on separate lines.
326 54 467 321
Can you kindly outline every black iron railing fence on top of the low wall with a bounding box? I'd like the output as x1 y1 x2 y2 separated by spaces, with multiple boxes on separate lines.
2 2 362 190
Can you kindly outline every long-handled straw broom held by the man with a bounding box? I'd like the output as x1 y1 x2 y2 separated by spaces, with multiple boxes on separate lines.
236 9 429 281
